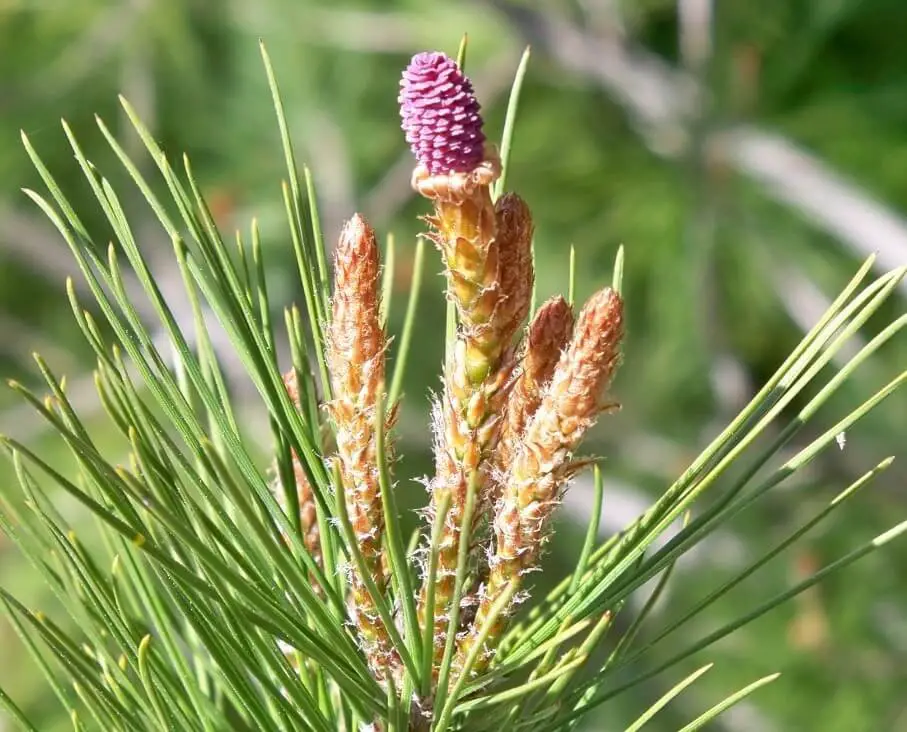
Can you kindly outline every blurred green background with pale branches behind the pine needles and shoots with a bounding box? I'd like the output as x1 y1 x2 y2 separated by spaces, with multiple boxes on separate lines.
0 0 907 732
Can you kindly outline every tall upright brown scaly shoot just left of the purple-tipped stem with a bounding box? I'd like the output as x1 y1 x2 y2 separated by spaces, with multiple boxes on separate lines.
326 214 399 678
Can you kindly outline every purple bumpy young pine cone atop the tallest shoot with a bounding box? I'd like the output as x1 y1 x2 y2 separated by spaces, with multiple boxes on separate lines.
397 52 485 175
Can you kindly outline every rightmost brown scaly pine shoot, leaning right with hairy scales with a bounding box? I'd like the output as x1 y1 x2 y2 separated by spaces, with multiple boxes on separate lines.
458 289 623 671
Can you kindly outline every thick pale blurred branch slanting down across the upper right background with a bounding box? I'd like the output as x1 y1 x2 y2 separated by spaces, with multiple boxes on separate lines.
484 0 907 293
